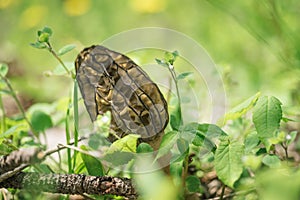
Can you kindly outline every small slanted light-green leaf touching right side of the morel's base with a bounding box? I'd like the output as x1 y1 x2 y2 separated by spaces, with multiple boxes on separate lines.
156 131 179 159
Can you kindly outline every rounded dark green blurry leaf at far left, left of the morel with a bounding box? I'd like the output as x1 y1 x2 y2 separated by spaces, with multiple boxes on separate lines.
31 111 53 132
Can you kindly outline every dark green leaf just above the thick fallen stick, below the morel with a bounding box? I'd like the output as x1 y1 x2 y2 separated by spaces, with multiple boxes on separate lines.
80 147 105 176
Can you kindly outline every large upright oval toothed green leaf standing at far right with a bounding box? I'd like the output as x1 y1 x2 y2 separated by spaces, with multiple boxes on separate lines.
252 96 282 151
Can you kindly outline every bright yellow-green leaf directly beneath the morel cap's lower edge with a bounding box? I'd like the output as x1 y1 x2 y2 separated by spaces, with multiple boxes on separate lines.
107 134 140 153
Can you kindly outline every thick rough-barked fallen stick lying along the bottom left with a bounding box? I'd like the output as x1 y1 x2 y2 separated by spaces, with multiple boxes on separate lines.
0 172 137 199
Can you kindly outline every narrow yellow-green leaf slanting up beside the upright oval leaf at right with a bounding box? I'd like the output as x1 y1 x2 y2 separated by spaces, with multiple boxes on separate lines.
224 92 260 123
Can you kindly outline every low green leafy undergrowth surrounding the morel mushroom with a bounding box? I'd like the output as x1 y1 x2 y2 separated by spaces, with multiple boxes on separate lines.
0 27 300 200
